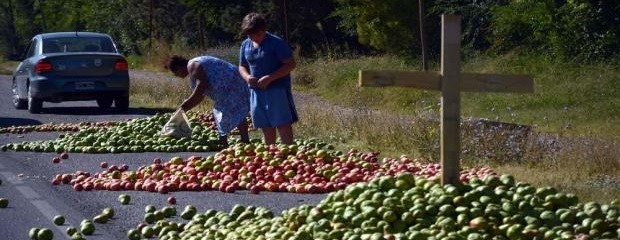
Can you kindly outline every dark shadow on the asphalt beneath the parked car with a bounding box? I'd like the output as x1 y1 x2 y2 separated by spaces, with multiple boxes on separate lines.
41 107 174 115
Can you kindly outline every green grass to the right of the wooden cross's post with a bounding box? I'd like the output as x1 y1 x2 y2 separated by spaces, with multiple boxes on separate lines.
464 55 620 138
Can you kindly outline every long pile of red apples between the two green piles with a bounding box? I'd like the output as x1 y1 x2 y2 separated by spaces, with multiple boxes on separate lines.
52 141 495 194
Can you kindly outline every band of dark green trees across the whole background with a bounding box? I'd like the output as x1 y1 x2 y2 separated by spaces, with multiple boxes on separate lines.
0 0 620 61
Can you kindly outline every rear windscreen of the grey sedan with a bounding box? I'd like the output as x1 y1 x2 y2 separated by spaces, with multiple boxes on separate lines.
43 37 116 53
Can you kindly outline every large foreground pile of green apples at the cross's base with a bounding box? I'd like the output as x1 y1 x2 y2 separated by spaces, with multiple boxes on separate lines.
128 173 620 240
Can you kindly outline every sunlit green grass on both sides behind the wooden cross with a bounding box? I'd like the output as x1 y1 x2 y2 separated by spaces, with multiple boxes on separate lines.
294 52 620 138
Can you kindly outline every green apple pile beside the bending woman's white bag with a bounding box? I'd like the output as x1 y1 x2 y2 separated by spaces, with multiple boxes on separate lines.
1 112 223 153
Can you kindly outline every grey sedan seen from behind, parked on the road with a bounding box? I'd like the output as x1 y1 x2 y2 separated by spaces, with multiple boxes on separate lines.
12 32 129 113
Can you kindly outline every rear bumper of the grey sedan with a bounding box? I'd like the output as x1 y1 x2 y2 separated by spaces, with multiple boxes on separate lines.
30 77 129 102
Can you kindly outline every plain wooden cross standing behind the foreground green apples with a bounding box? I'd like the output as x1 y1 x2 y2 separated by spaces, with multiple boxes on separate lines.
359 15 534 184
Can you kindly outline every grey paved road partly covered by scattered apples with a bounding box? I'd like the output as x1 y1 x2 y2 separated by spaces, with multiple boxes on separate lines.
0 75 325 240
